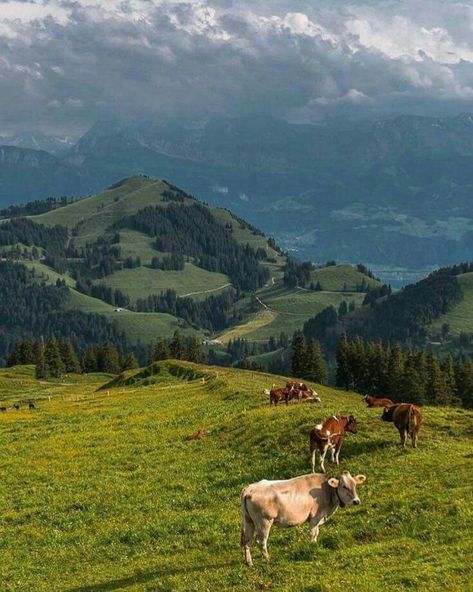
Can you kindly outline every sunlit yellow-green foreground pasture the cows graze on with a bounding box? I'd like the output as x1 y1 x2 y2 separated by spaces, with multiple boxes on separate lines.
0 362 473 592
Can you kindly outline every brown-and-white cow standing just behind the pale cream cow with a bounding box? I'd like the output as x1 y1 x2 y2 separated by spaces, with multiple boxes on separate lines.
309 415 357 473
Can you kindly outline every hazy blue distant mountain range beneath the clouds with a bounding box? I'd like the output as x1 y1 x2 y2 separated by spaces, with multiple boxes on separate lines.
0 114 473 270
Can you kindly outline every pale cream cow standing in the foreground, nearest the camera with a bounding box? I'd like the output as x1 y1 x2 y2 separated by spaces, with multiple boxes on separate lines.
240 471 366 566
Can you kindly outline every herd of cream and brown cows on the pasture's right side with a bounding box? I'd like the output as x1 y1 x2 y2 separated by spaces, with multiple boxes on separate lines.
241 382 422 566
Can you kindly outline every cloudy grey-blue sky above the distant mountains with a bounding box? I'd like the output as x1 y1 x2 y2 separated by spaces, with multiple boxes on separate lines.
0 0 473 134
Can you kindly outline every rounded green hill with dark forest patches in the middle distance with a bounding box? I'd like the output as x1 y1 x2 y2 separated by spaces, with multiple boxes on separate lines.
0 177 384 352
